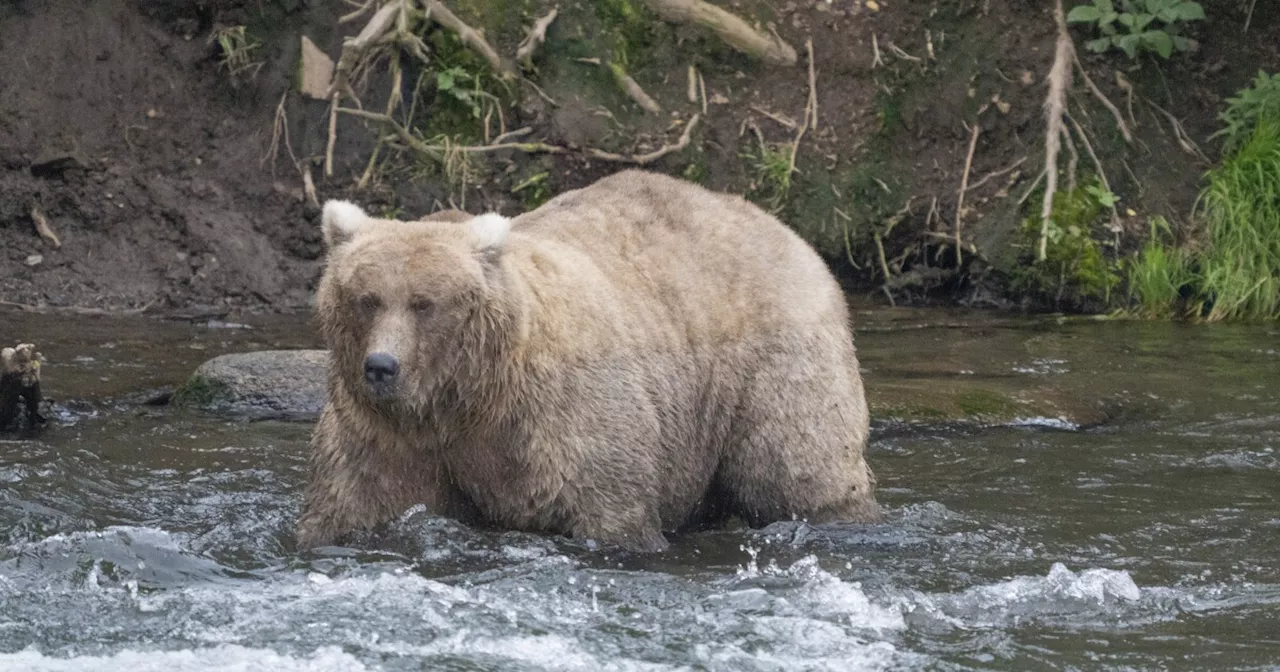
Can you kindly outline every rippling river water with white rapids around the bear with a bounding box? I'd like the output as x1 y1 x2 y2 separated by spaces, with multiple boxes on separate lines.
0 305 1280 672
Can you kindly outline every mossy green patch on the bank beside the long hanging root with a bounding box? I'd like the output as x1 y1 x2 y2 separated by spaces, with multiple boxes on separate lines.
1010 176 1120 305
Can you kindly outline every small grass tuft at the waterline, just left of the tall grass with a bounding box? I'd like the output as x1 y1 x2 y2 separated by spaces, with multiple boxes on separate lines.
1125 216 1198 319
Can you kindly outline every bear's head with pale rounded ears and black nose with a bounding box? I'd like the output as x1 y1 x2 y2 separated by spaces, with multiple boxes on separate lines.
316 201 511 410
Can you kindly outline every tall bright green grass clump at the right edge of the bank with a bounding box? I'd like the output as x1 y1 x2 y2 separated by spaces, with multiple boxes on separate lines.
1197 116 1280 320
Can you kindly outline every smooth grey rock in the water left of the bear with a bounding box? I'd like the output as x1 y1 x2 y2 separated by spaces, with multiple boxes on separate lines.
173 349 329 420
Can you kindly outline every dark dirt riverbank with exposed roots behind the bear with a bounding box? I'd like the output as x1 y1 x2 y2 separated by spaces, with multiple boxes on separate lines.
0 0 1280 311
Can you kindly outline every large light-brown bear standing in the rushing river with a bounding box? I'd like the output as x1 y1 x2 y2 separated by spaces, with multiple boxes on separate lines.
297 170 881 550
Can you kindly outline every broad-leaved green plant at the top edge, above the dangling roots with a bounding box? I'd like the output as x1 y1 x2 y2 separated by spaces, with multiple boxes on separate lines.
1066 0 1204 59
